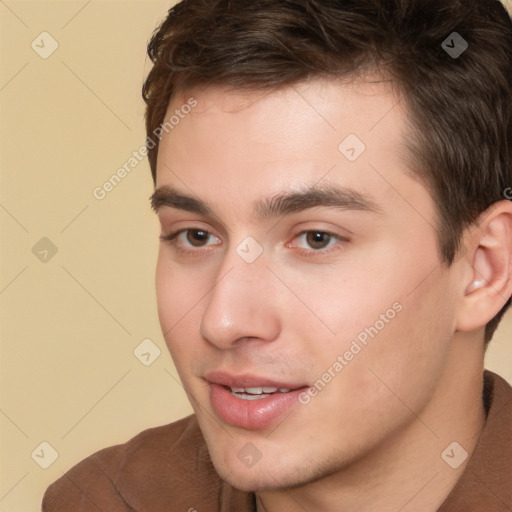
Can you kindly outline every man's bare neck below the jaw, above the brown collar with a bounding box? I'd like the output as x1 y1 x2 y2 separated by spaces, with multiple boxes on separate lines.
257 339 485 512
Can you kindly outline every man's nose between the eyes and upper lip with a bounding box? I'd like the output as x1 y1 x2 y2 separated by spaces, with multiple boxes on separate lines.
200 250 281 349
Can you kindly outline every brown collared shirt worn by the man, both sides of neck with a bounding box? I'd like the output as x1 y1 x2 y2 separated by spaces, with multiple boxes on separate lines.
42 371 512 512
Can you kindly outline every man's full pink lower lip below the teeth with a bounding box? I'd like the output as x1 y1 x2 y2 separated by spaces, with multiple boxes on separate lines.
210 382 307 430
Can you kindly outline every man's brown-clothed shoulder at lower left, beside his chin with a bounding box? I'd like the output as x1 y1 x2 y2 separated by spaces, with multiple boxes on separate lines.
42 416 246 512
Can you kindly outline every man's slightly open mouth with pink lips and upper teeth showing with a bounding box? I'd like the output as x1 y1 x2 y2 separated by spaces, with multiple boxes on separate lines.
205 372 309 430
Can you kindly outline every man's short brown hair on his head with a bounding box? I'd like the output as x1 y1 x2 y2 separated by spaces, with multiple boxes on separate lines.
143 0 512 342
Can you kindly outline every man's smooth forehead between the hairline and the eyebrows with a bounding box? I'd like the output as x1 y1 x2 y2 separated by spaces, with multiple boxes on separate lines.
153 79 432 224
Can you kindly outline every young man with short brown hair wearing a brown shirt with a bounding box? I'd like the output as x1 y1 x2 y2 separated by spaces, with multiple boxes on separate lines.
43 0 512 512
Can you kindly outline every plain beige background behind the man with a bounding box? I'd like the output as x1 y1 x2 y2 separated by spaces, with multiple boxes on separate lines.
0 0 512 512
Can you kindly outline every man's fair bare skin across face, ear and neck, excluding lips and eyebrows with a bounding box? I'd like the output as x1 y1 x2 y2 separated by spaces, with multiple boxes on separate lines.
152 79 512 512
